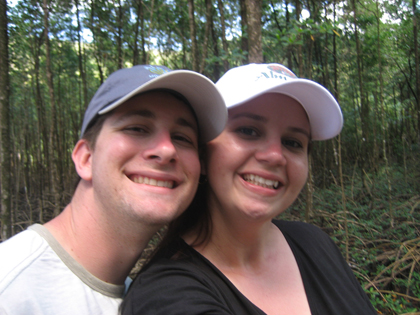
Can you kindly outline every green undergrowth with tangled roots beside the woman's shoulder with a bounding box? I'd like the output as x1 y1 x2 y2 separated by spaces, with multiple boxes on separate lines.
281 166 420 315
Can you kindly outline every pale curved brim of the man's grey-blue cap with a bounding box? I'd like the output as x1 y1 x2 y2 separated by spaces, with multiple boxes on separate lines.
99 70 227 142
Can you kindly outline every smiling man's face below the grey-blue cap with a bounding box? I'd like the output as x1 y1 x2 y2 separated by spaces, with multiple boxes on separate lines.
81 92 200 225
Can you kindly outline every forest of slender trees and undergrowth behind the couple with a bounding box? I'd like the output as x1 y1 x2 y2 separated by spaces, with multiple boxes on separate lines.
0 0 420 314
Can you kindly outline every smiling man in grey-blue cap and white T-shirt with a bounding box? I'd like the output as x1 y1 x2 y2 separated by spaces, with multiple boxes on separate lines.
0 66 227 314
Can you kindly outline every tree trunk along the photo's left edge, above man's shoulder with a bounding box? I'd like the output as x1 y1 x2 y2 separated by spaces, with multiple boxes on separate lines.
0 0 13 240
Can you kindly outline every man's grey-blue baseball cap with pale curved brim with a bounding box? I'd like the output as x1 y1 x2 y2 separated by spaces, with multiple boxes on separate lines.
81 65 227 142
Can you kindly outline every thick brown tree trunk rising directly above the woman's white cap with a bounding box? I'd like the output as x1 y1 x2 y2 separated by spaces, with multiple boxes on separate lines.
245 0 264 63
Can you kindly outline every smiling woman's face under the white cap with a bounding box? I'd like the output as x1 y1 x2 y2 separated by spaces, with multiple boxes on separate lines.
206 93 310 220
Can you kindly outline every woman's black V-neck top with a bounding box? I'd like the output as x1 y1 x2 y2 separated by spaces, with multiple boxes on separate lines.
122 220 376 315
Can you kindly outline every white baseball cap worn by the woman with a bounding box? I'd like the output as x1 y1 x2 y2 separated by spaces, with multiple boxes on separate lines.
216 63 343 140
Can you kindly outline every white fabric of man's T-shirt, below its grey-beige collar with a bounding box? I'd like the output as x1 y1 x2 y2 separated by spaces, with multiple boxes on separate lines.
0 225 121 314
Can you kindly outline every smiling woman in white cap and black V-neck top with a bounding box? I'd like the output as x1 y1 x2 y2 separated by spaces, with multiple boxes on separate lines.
122 64 376 315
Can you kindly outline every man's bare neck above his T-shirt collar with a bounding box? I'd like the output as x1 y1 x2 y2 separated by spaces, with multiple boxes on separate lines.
45 198 155 284
